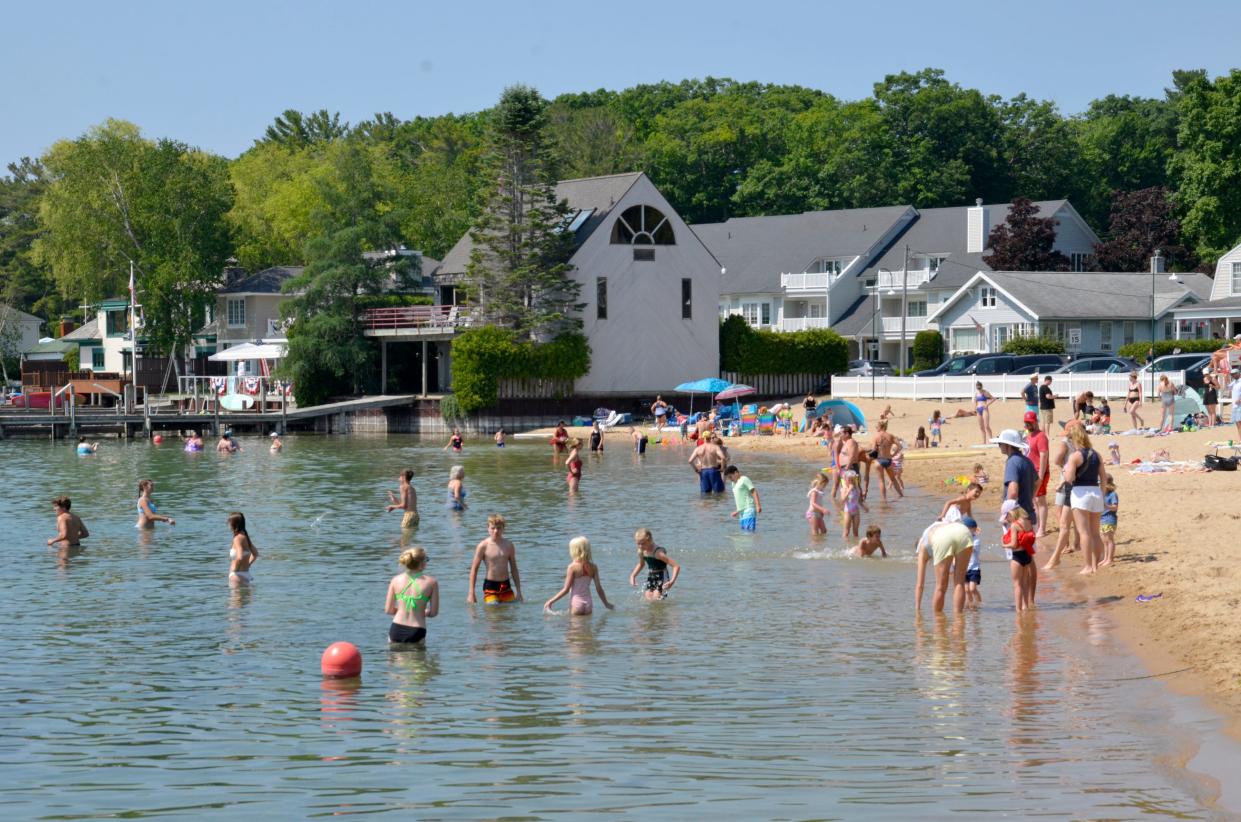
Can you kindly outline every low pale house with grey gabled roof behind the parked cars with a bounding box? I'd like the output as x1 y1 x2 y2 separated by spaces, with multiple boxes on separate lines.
927 264 1211 354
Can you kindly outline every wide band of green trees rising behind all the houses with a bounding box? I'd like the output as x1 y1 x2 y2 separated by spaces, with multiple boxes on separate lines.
0 68 1241 350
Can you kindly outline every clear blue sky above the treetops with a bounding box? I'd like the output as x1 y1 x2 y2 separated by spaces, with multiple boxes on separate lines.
0 0 1241 164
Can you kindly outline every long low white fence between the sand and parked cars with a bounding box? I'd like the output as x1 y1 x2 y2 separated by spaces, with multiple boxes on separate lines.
831 371 1186 404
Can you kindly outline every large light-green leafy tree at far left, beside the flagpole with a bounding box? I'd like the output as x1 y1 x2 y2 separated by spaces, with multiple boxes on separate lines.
35 120 232 354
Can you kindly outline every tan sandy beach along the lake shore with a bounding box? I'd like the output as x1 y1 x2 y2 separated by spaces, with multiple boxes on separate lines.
538 400 1241 734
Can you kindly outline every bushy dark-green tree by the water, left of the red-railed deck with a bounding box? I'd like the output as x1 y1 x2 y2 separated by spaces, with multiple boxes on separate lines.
282 140 421 405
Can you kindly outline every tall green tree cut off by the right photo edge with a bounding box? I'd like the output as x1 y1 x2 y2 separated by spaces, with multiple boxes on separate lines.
1172 68 1241 261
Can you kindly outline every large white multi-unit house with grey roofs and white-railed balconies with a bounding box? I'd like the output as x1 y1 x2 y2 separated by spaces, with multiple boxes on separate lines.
695 200 1098 365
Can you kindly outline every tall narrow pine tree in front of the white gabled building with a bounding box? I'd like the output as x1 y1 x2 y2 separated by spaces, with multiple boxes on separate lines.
465 86 582 339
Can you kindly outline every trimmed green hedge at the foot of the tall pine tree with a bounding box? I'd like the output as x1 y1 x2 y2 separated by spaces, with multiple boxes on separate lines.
452 325 591 413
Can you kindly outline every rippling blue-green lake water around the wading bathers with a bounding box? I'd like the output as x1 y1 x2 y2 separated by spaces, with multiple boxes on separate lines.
0 437 1241 820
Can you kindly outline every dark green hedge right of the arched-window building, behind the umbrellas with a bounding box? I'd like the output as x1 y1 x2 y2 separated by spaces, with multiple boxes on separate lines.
720 315 849 374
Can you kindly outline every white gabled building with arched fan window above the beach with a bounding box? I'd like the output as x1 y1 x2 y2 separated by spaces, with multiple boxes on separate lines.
437 171 721 395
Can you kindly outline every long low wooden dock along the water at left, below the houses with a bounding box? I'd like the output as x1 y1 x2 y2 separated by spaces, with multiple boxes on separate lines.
0 394 421 438
